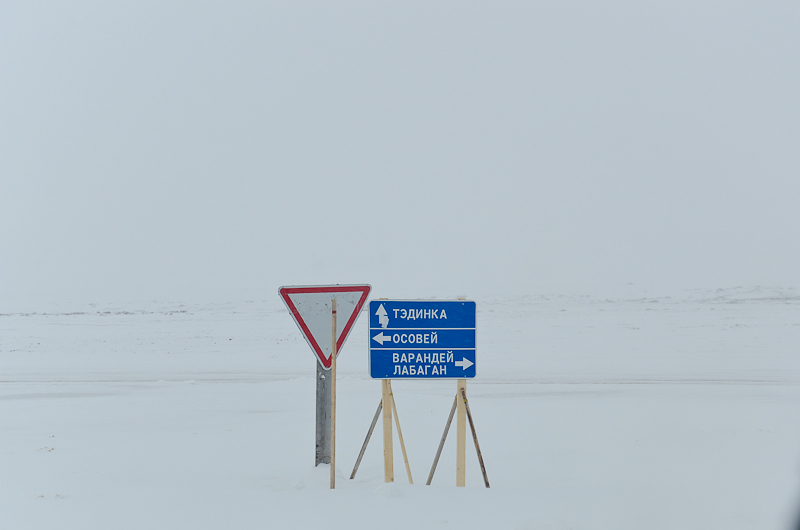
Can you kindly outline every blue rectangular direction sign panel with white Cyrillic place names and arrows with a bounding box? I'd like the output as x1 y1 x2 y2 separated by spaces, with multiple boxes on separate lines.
369 300 475 379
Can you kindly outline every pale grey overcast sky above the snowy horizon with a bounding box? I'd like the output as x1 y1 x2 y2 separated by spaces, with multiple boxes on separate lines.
0 0 800 308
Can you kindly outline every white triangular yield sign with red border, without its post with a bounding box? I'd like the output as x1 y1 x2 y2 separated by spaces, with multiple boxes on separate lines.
280 285 372 370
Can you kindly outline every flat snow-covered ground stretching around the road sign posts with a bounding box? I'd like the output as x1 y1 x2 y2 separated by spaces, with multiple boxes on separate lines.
0 289 800 530
